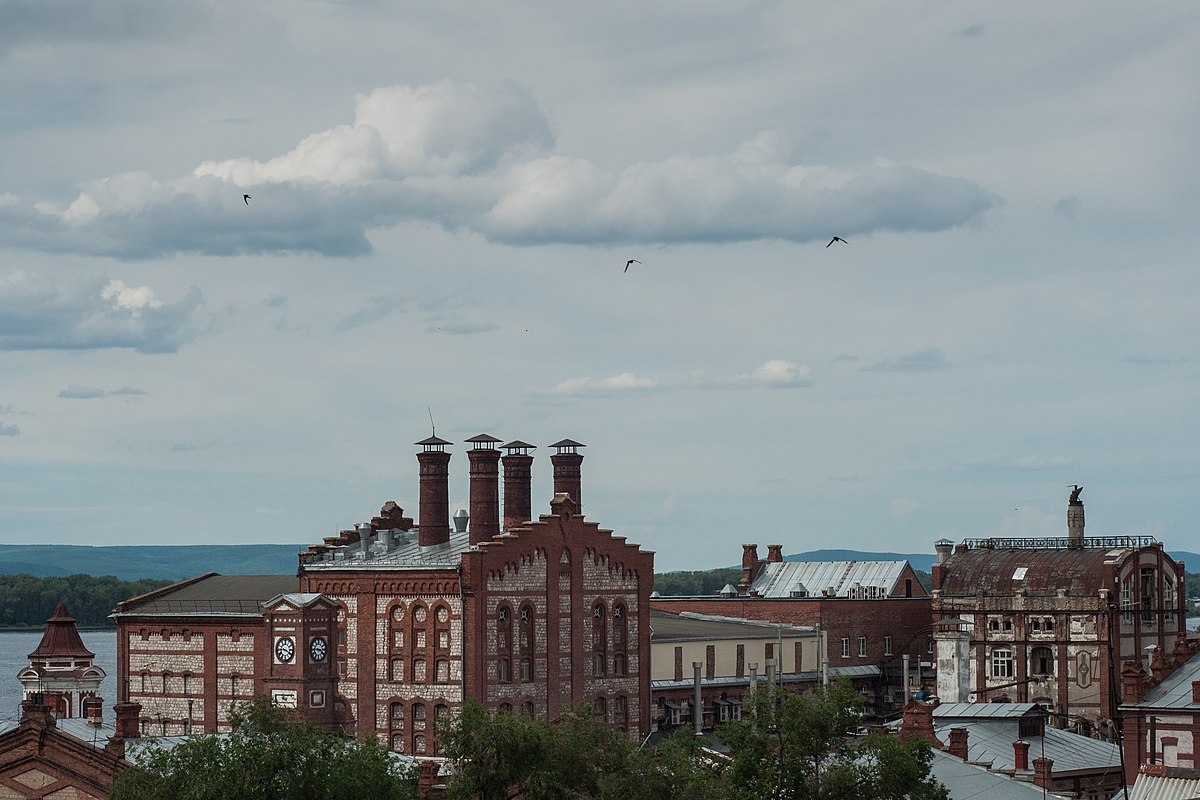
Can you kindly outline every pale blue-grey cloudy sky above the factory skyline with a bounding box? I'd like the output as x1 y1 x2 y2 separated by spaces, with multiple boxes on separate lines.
0 0 1200 571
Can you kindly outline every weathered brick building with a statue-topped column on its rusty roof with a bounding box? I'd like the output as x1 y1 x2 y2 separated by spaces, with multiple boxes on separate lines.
932 487 1187 735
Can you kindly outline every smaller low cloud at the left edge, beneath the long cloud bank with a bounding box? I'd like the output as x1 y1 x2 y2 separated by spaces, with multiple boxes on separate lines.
0 271 204 352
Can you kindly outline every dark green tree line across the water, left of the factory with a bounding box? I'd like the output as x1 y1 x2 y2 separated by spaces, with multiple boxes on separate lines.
0 575 174 628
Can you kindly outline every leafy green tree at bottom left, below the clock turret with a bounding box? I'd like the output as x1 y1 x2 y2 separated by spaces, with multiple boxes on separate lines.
109 697 416 800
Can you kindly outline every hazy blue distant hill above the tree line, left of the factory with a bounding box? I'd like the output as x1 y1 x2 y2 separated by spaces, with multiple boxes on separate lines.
0 545 305 581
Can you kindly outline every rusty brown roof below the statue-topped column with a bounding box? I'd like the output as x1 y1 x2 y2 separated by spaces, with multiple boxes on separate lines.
941 547 1133 597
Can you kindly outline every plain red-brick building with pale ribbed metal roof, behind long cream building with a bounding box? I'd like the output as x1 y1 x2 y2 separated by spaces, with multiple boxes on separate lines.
652 545 932 716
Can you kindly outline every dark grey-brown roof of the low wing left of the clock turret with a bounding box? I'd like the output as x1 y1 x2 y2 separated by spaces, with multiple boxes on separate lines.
114 575 300 616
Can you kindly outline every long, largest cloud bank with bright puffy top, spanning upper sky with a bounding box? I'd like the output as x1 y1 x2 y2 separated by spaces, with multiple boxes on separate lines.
0 82 1001 259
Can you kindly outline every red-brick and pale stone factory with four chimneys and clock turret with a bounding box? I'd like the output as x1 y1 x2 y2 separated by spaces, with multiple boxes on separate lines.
114 435 654 756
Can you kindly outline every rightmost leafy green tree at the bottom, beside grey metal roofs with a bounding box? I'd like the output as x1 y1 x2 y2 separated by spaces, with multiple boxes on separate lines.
719 680 948 800
